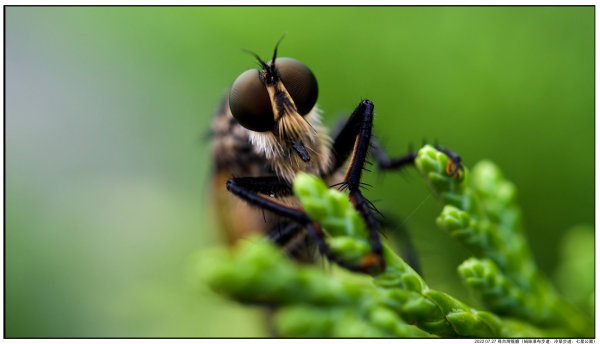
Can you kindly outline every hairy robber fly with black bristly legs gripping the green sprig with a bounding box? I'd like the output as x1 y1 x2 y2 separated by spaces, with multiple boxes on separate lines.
212 40 462 272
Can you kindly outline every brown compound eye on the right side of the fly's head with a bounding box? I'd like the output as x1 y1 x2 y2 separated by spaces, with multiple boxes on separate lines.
275 57 319 116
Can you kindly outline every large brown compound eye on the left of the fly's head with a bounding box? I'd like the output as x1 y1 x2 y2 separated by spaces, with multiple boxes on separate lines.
229 69 275 131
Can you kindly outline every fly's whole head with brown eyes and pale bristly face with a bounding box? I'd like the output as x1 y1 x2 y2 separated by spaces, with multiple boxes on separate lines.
229 57 330 181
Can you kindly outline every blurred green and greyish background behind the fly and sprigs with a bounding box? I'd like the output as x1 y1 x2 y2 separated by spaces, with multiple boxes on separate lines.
5 7 594 337
